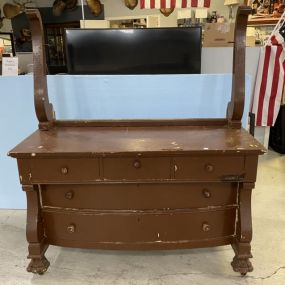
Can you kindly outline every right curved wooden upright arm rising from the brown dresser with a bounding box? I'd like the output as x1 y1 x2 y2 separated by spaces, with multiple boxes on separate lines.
227 6 251 128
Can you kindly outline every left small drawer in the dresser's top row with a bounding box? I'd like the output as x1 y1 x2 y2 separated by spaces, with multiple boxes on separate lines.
30 159 99 183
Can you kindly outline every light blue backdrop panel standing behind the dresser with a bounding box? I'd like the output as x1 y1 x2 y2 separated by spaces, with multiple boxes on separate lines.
0 74 250 209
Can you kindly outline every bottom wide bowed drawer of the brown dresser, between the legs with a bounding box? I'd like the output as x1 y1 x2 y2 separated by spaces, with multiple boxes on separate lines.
43 208 236 246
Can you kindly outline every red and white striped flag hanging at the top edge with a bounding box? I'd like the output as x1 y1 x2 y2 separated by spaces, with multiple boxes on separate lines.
140 0 211 9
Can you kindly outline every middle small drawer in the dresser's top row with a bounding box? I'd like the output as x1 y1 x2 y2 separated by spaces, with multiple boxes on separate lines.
104 157 171 180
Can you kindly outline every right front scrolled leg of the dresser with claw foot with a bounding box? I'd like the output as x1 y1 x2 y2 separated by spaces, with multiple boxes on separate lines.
231 183 254 275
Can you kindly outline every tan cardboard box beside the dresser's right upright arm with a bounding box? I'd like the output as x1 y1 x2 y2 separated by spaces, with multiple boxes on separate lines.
203 23 235 47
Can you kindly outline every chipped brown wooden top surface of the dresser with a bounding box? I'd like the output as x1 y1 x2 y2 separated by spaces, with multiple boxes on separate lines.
9 126 266 158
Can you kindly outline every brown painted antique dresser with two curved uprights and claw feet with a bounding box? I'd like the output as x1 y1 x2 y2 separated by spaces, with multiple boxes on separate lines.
9 7 265 275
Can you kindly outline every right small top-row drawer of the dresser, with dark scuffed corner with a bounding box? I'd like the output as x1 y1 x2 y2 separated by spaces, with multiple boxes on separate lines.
173 156 245 181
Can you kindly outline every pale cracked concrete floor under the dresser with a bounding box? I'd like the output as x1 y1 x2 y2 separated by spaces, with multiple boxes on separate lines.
0 152 285 285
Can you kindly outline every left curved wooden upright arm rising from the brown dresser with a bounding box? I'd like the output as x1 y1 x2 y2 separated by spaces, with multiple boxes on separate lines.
26 9 53 130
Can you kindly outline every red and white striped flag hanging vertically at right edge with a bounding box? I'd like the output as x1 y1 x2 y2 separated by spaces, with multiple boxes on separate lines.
251 25 285 126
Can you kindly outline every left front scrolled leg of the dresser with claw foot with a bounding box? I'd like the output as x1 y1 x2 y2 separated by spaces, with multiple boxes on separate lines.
23 185 50 274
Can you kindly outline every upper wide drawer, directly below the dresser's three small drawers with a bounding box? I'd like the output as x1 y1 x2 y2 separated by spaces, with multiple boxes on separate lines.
41 183 237 210
